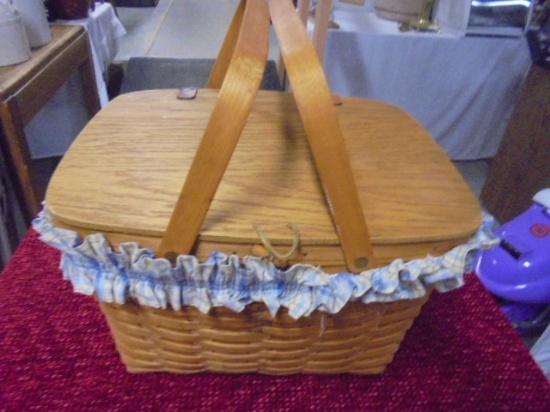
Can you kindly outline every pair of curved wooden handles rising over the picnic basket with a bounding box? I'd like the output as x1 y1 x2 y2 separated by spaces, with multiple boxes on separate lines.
157 0 374 272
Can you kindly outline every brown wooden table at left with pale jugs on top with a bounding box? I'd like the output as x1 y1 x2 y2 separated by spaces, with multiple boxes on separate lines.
0 25 100 224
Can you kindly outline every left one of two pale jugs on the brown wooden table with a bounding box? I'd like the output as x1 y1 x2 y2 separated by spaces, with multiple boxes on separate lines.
0 0 31 66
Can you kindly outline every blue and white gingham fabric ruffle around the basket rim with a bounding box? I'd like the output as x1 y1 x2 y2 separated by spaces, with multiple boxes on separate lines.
33 208 498 319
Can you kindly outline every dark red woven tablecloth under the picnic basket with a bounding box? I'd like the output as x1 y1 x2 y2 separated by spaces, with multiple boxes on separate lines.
0 231 550 412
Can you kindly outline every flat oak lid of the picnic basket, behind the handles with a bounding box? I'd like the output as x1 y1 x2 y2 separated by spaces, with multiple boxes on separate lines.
46 89 481 264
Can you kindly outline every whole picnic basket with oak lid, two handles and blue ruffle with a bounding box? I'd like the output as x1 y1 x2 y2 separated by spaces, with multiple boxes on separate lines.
35 0 490 374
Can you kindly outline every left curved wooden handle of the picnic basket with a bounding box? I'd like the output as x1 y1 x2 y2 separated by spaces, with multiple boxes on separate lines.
157 0 269 260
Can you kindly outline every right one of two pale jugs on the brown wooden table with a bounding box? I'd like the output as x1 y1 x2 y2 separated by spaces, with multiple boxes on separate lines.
12 0 52 48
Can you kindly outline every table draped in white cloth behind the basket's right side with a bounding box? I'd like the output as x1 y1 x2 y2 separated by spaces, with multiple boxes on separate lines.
324 7 531 160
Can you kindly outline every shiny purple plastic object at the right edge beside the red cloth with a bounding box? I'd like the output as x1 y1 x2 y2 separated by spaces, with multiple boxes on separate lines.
474 189 550 304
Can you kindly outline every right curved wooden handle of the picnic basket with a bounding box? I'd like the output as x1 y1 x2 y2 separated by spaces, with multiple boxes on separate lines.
268 0 374 272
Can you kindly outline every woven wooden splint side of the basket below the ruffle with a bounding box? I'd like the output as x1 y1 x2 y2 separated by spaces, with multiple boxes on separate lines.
100 297 434 375
